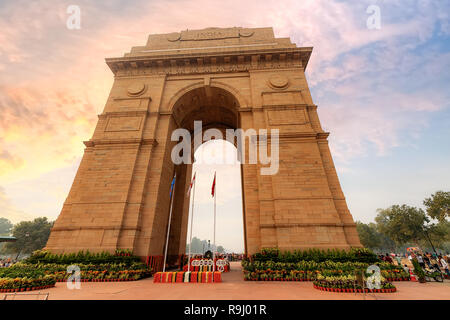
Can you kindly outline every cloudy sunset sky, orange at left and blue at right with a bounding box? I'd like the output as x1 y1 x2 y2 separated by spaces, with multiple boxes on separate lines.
0 0 450 251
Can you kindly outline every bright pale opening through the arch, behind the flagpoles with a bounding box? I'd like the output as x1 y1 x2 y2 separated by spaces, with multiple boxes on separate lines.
186 140 244 254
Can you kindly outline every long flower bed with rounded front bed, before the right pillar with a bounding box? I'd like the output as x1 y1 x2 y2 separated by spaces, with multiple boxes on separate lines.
242 249 402 292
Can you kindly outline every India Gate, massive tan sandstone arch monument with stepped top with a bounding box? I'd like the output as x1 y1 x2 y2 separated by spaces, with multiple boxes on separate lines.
46 27 361 268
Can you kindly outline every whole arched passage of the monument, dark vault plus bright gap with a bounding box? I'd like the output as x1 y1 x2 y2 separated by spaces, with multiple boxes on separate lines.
162 86 246 266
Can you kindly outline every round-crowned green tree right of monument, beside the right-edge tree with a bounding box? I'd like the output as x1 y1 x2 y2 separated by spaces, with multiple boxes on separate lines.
375 204 430 245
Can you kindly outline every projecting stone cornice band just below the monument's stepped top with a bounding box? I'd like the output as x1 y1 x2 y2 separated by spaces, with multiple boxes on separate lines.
105 47 312 77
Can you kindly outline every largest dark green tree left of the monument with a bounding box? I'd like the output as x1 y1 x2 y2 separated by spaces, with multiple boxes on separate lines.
5 217 53 254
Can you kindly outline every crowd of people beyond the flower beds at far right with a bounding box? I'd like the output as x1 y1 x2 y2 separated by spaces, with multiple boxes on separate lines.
379 252 450 276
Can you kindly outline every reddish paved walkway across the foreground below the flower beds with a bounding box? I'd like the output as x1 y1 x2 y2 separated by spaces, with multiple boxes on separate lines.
4 262 450 300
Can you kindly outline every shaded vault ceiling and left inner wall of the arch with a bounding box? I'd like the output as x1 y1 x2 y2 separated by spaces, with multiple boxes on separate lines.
156 83 245 265
